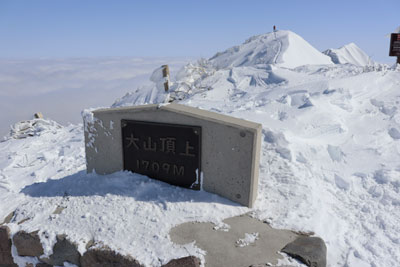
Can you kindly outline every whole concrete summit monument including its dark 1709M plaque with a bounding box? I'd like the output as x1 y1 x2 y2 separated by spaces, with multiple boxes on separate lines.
84 103 262 207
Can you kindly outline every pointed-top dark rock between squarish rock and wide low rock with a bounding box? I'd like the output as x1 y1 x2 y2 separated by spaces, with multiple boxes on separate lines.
40 235 81 266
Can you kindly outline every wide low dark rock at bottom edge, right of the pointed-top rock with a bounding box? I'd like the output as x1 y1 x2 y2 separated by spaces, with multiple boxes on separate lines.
81 249 143 267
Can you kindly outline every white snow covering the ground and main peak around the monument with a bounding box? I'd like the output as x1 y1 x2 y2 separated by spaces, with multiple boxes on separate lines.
0 31 400 266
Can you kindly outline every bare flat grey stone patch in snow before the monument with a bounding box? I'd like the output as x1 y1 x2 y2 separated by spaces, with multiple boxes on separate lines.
170 215 297 267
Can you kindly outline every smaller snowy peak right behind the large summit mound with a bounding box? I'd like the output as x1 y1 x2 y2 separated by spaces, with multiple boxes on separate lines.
323 43 373 66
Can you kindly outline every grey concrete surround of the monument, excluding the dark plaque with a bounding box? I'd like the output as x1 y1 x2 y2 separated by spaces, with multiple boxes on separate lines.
84 104 262 207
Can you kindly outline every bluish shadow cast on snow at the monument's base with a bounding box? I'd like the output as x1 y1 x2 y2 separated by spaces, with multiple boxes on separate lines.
21 170 239 206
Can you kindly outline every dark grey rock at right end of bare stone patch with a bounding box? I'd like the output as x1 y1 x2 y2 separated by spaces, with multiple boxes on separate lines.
282 236 327 267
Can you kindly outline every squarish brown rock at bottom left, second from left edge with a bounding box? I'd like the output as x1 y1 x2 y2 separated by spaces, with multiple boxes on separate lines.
13 231 44 257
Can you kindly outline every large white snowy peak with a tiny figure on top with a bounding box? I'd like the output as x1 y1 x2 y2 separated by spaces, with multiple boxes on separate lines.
210 30 332 69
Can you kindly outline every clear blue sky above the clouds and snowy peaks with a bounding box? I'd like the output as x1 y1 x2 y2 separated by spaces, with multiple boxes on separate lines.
0 0 400 63
